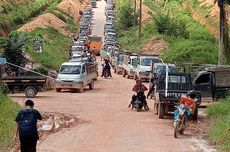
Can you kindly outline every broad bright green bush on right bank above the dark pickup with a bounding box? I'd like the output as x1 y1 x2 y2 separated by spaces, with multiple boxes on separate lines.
162 39 218 64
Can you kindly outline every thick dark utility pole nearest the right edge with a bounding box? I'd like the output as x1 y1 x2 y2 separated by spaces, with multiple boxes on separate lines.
218 0 226 64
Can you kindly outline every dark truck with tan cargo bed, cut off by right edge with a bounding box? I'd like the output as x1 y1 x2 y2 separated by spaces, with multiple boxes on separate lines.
194 66 230 101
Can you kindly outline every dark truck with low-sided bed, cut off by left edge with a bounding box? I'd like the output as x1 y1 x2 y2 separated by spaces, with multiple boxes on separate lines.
0 63 47 98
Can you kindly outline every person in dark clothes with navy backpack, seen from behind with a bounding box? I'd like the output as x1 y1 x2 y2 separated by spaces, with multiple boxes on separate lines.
14 100 42 152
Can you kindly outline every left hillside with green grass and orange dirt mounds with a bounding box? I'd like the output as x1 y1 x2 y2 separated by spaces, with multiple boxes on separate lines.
0 0 88 69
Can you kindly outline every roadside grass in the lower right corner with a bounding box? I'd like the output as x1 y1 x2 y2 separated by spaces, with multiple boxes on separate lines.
207 96 230 152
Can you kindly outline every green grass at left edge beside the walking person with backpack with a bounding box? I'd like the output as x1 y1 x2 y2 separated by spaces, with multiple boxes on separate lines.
0 93 20 151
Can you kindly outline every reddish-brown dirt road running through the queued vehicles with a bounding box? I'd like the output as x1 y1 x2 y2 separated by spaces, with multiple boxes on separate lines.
12 0 215 152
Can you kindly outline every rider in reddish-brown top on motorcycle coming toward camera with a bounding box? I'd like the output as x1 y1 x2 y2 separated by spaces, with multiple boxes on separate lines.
128 79 149 110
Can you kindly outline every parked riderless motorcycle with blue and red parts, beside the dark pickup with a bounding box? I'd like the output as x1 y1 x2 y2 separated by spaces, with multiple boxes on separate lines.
174 104 190 138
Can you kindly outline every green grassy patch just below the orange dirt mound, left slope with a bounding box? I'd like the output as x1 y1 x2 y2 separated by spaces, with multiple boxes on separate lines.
25 29 71 69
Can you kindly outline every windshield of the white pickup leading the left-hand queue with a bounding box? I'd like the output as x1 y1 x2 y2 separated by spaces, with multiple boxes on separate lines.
59 65 81 74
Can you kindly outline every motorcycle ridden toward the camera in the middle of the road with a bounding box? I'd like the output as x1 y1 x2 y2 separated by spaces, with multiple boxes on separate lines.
132 91 149 112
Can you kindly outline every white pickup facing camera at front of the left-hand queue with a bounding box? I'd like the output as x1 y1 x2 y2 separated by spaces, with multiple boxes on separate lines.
55 62 98 93
